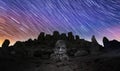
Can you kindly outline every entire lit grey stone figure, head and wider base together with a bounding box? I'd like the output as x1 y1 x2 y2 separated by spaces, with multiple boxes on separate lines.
51 40 68 62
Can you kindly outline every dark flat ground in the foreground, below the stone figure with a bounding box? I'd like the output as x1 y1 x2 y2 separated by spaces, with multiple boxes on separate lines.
0 56 120 71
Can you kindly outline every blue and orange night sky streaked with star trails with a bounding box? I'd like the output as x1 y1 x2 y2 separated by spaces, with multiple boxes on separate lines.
0 0 120 44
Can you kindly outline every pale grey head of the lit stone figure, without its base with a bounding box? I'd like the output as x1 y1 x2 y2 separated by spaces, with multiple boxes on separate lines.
54 40 67 54
